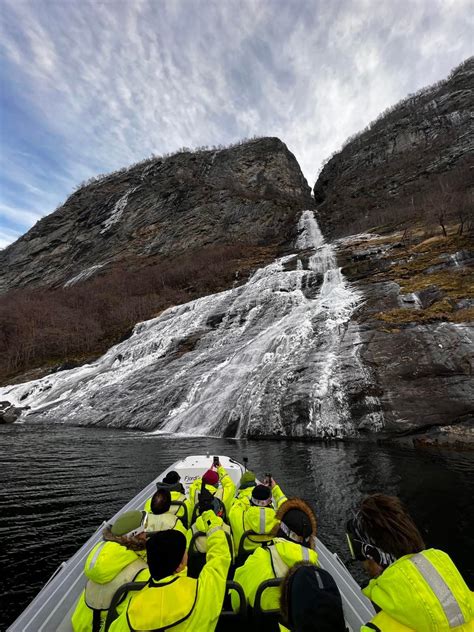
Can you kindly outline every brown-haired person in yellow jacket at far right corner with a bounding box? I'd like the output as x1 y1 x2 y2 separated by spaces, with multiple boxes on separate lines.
347 494 474 632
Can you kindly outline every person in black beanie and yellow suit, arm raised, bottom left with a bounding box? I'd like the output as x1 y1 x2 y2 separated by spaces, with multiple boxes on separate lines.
110 510 230 632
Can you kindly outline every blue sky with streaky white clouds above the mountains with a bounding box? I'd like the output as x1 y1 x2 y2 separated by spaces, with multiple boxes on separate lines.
0 0 474 248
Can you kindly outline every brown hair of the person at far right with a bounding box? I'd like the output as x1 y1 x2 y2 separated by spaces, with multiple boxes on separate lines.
357 494 425 559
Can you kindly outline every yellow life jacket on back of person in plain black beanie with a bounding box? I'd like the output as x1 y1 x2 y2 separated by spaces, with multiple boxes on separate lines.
127 576 199 632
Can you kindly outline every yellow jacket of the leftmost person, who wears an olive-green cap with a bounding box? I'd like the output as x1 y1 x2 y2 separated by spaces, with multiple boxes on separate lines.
71 540 150 632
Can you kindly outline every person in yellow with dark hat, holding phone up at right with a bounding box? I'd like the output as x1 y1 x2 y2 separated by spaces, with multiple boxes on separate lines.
229 478 287 555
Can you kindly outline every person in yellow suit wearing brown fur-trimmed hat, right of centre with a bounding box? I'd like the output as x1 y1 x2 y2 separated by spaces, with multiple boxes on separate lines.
231 498 318 610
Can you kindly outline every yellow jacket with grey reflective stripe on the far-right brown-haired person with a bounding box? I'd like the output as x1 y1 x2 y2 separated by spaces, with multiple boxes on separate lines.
361 549 474 632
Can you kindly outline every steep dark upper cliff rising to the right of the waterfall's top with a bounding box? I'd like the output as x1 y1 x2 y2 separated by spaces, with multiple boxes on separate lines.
314 57 474 237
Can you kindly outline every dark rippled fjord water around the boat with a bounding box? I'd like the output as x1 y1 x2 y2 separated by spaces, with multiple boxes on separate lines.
0 425 474 630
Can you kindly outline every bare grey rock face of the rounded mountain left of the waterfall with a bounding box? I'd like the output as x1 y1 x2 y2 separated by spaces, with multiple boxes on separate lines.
0 138 312 292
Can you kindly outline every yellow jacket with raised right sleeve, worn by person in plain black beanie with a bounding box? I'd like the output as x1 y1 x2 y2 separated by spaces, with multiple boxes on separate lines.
110 512 230 632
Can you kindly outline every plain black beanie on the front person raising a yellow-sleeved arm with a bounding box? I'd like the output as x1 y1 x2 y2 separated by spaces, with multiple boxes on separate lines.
146 529 186 580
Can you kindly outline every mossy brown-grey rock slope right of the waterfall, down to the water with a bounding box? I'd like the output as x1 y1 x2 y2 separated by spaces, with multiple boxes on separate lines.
338 233 474 445
